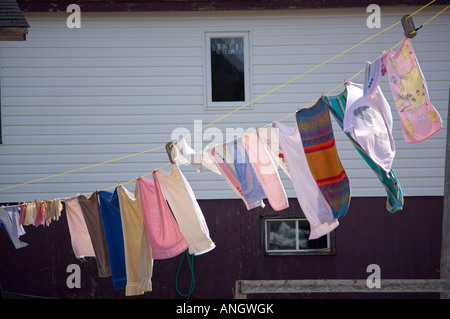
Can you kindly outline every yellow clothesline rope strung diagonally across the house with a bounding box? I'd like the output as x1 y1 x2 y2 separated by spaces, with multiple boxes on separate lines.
0 0 442 198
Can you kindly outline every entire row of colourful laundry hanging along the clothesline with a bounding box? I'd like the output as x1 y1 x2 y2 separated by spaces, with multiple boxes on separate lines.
0 1 450 296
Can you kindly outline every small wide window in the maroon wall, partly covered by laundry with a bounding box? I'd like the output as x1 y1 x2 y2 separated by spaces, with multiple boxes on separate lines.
264 218 332 255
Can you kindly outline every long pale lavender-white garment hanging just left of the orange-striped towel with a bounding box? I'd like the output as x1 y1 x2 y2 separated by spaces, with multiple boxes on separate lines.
274 122 339 240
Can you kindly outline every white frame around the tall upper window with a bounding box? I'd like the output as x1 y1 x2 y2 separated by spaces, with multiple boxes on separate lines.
203 30 253 110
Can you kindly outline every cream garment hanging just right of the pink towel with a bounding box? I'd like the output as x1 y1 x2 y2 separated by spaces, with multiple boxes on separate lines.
153 164 216 255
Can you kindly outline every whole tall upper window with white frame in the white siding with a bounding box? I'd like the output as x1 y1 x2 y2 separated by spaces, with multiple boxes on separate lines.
205 32 250 109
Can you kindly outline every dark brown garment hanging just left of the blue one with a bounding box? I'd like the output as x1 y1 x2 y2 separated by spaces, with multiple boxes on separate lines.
78 192 111 277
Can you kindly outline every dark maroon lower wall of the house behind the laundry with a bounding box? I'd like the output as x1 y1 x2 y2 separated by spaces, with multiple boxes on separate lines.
0 197 443 299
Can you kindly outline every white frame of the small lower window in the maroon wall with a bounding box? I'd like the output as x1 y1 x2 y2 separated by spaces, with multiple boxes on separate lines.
264 218 332 255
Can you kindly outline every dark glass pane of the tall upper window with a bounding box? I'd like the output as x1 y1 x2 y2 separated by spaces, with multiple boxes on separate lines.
211 38 245 102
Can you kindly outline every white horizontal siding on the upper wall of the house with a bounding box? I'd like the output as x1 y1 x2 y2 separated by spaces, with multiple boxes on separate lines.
0 6 450 202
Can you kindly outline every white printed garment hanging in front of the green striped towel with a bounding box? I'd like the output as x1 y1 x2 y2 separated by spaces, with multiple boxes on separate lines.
343 82 395 173
